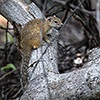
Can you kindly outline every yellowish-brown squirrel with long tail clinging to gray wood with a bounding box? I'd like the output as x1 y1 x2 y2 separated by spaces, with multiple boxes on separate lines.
20 16 63 88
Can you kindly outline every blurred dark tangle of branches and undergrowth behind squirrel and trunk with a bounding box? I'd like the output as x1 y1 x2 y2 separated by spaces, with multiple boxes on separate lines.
0 0 100 100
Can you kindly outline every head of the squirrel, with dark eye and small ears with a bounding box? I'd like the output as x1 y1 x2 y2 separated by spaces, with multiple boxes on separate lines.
46 16 63 28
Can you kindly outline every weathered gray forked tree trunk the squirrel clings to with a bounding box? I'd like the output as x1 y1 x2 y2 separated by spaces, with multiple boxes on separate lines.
0 0 100 100
